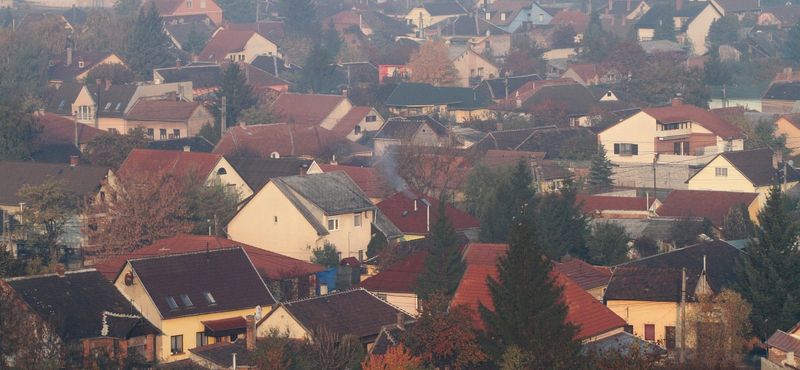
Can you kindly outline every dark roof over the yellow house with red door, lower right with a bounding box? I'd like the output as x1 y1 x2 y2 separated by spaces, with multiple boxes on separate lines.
605 241 742 302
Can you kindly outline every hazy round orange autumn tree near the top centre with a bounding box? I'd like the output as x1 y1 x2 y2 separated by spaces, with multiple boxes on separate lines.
408 40 458 86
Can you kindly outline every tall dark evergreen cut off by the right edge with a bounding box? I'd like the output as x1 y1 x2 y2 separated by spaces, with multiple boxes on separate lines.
737 185 800 339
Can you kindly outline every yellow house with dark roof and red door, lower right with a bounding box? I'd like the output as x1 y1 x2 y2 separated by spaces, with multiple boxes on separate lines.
605 241 742 349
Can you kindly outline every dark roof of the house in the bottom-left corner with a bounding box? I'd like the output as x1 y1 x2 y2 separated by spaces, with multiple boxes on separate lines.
5 269 158 340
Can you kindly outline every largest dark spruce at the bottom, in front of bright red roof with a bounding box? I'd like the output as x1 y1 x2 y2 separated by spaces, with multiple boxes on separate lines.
478 206 581 369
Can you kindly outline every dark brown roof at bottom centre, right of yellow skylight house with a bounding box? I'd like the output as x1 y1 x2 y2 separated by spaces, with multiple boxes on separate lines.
273 289 413 341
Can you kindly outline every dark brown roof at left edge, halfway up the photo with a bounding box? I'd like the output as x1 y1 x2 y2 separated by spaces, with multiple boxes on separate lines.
0 161 108 206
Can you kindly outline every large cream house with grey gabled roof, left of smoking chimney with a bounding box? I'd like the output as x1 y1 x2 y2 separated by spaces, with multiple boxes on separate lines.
228 171 402 260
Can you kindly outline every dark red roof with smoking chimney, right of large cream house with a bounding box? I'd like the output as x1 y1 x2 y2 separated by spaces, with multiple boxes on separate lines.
377 189 480 235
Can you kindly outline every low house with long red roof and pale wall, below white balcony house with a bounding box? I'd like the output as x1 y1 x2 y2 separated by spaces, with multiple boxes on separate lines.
575 194 661 219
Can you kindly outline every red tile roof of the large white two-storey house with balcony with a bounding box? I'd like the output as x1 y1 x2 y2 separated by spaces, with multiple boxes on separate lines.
644 104 745 139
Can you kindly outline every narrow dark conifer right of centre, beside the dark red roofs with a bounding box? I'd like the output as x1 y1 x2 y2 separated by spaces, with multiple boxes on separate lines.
412 199 466 301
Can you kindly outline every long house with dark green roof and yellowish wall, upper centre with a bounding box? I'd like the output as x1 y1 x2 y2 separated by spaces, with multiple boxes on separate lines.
384 82 493 122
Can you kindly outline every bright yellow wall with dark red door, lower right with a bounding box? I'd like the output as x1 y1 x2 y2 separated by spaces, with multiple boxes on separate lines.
606 301 678 343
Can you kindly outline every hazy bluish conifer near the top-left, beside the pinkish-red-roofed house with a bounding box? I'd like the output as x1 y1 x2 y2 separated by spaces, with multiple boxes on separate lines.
127 2 173 78
